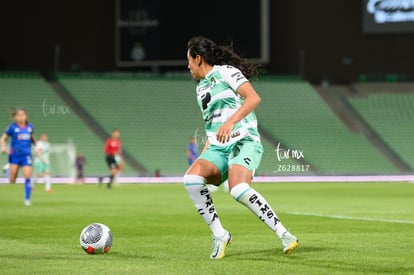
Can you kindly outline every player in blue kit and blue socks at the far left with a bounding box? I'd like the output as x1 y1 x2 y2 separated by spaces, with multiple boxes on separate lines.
0 108 36 206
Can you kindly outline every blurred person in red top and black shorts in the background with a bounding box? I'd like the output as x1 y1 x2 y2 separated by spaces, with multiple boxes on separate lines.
99 129 123 189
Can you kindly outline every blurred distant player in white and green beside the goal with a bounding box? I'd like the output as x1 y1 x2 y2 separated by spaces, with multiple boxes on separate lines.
33 133 52 192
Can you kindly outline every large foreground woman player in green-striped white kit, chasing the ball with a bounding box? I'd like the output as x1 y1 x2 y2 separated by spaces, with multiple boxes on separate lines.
184 37 299 259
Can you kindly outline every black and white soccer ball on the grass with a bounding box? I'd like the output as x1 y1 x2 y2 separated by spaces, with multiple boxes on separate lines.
80 223 112 254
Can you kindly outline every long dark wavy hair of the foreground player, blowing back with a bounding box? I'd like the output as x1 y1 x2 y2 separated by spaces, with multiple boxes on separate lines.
187 36 260 79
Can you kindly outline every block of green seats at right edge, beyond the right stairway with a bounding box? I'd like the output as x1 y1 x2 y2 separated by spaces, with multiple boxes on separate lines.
348 84 414 168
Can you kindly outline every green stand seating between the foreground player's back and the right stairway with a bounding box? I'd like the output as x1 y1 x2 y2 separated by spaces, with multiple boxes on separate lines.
254 77 398 175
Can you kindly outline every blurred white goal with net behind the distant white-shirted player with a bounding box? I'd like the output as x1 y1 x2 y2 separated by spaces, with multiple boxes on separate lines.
49 139 76 179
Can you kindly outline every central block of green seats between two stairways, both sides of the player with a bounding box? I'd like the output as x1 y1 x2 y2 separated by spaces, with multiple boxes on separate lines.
59 74 398 175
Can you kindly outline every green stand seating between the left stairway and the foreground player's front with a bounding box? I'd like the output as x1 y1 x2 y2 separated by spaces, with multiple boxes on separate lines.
59 74 204 175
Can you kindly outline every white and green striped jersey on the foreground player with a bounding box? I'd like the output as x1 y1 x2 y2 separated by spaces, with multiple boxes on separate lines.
197 65 260 146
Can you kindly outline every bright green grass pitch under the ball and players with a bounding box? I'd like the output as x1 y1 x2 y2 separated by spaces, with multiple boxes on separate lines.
0 183 414 274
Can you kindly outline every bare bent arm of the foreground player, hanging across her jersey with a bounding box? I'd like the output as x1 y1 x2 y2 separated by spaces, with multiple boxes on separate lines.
217 81 261 143
